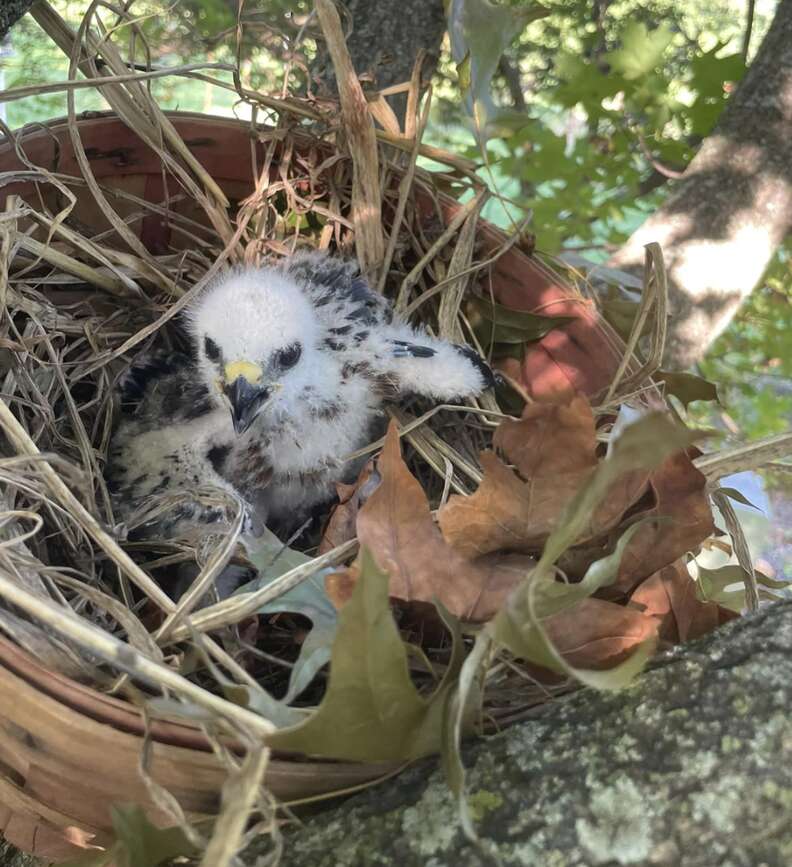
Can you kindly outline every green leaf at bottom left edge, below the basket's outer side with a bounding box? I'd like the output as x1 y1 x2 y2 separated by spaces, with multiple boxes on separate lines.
61 804 198 867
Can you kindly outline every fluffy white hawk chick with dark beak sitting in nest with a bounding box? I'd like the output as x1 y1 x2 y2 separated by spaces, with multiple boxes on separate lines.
107 252 493 536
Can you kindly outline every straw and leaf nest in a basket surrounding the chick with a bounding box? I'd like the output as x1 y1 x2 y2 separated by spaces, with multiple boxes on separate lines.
0 10 768 863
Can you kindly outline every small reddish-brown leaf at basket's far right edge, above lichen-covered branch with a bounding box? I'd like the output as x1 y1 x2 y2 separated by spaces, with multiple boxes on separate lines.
630 558 738 644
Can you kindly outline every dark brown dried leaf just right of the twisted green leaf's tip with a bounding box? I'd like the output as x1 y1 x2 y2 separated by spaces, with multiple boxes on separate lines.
615 452 715 592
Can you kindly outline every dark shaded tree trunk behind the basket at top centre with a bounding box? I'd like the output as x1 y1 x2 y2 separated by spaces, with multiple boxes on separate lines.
311 0 446 120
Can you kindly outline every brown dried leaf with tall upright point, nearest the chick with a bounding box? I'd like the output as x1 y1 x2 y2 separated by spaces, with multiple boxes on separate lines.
325 423 533 623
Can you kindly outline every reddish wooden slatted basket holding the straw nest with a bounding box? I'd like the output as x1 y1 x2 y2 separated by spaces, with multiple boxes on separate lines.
0 114 632 860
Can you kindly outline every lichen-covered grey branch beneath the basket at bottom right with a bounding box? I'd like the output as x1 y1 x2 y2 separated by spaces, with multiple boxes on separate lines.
244 601 792 867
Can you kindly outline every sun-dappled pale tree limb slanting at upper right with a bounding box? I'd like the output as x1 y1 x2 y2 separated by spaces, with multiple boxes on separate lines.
608 0 792 368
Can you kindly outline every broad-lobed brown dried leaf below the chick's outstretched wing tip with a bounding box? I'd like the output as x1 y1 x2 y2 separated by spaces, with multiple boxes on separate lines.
438 396 648 558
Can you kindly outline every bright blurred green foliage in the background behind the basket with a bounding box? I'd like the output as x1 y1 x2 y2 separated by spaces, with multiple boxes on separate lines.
2 0 792 448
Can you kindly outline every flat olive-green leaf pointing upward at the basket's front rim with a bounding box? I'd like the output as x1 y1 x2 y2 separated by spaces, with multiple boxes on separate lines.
268 549 462 762
